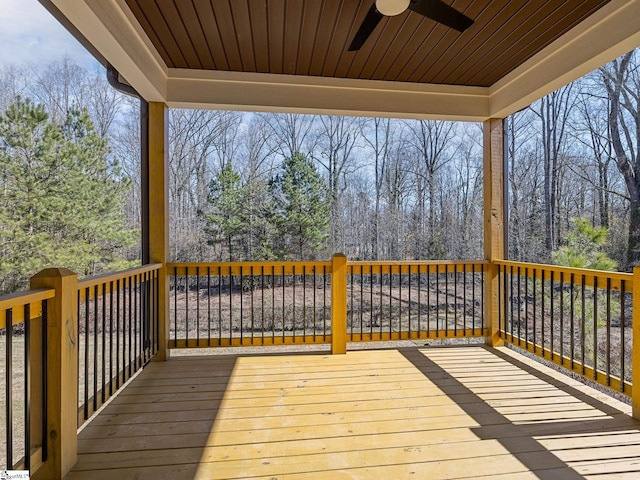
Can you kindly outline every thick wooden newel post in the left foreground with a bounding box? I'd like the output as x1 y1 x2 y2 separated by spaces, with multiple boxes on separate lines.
31 268 78 479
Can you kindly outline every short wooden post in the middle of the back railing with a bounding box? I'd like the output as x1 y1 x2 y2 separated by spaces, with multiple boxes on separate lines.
331 253 347 354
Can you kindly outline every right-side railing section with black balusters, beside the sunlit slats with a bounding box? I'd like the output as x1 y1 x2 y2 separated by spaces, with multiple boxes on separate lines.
496 261 634 396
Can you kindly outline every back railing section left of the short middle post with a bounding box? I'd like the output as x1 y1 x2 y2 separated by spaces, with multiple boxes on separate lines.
167 262 333 348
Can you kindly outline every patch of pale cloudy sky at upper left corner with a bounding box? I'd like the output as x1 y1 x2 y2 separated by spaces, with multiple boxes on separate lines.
0 0 98 69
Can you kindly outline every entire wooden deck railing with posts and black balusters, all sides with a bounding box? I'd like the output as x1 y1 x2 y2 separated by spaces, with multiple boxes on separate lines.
0 255 640 479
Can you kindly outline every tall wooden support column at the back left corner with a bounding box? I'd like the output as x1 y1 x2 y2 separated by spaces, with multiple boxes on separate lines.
148 102 169 361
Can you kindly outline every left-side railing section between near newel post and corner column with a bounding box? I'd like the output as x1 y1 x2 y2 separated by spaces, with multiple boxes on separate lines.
77 264 160 426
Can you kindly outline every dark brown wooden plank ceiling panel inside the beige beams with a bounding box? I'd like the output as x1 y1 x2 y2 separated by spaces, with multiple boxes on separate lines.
126 0 608 87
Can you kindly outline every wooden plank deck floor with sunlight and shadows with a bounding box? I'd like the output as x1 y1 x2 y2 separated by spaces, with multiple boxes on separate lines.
67 346 640 480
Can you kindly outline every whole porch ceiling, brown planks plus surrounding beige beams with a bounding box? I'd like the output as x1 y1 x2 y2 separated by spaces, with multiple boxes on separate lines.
40 0 640 120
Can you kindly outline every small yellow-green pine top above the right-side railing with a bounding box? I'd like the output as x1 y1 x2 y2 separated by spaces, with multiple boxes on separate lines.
551 218 618 270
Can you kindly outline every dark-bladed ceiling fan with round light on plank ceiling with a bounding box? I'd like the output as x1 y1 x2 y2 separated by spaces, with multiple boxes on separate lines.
349 0 473 52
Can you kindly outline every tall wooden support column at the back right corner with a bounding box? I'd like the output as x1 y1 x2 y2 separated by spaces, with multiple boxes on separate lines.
483 118 505 347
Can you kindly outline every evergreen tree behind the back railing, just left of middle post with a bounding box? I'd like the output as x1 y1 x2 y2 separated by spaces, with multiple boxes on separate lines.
271 152 331 260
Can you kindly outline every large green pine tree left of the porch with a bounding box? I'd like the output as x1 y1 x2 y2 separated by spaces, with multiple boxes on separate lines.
0 99 134 291
